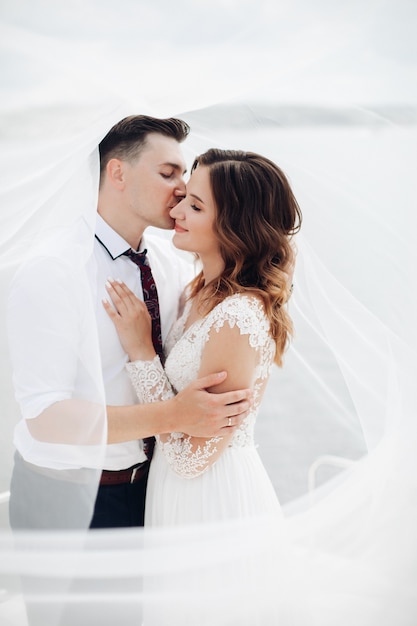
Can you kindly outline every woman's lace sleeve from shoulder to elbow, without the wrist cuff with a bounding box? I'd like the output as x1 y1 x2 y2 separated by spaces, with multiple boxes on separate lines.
159 294 275 478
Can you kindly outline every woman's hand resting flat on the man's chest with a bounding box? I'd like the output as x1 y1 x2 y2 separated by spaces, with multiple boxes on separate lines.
103 279 155 361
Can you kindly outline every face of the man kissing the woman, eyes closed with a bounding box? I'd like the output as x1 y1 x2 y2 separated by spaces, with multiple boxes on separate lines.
124 133 185 229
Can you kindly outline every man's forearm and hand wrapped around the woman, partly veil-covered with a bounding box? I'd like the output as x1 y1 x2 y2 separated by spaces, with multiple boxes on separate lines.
26 372 252 445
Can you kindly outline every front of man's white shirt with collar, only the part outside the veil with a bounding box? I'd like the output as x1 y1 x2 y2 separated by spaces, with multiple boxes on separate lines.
89 215 193 469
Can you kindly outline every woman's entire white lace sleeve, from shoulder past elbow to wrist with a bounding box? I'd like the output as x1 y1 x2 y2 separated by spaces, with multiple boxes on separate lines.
127 295 275 479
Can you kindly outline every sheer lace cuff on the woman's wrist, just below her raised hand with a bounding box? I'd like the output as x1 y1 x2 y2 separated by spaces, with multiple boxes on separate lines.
126 356 175 404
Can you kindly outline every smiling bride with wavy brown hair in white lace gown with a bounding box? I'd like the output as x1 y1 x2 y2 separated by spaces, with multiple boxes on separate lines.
104 149 301 525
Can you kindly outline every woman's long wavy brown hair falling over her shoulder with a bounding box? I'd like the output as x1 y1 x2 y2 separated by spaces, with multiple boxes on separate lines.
190 149 302 365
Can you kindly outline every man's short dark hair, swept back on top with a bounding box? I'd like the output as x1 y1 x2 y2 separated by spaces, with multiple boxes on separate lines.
98 115 190 175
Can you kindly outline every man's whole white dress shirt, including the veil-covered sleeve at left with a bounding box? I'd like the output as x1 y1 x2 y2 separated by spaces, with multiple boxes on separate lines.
8 215 194 470
